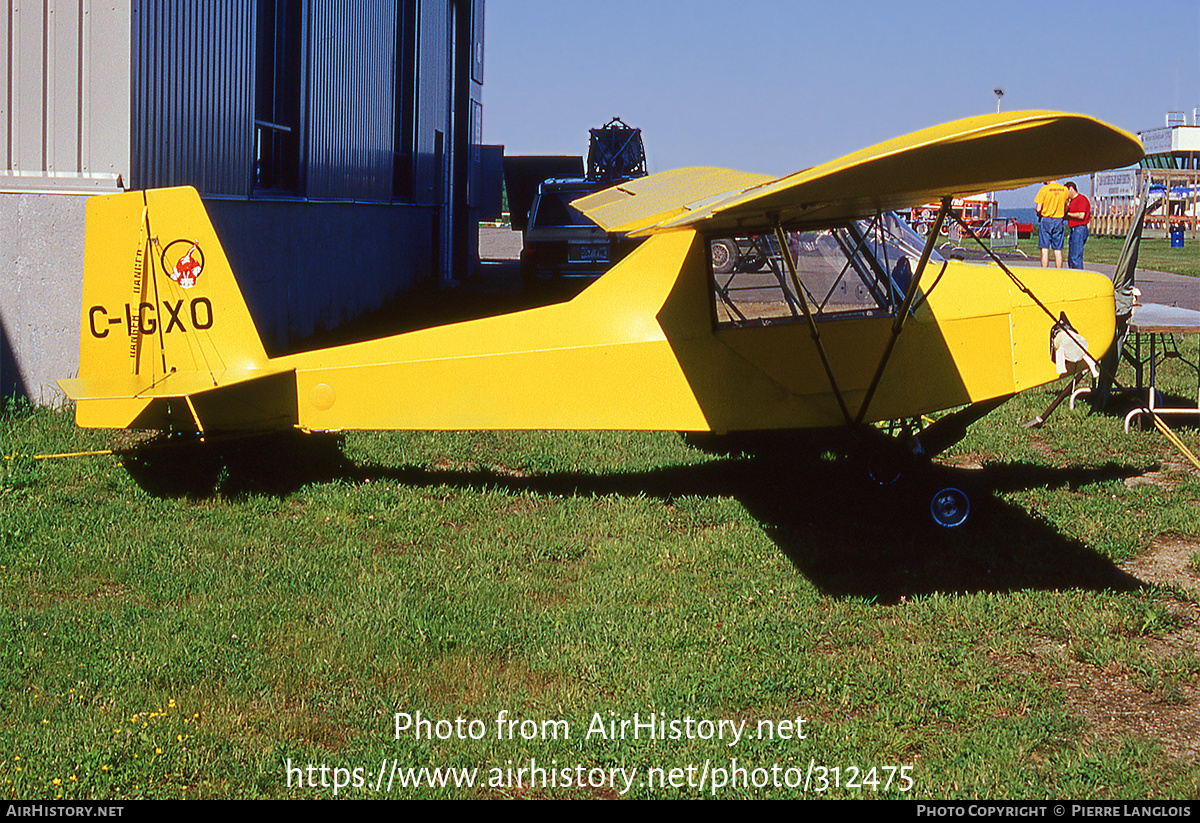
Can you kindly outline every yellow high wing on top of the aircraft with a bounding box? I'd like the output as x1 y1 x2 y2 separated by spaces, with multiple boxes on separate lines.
572 112 1142 234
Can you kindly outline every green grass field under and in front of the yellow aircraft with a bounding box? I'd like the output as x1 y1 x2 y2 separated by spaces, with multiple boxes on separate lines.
0 345 1200 799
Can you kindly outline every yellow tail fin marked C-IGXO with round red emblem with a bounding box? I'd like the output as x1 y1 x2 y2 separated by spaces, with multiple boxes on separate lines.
59 188 269 427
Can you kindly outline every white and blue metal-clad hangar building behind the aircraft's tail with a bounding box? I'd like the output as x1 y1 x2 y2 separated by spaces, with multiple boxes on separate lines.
0 0 484 402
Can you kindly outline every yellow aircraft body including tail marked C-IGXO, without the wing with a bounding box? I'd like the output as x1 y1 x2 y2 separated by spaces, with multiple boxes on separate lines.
61 190 1114 432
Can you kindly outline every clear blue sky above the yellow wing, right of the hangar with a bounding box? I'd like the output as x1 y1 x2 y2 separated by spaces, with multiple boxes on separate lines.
484 0 1200 206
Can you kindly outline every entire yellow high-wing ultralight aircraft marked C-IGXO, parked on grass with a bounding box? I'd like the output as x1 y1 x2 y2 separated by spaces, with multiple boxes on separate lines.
59 112 1142 525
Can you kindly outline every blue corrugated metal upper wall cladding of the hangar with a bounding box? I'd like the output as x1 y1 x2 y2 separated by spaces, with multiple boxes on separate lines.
130 0 479 215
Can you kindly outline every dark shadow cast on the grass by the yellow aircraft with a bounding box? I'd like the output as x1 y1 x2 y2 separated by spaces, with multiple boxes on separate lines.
125 432 1142 602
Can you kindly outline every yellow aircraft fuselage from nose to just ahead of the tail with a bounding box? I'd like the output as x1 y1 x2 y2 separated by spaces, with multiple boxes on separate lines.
272 232 1114 432
